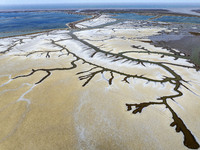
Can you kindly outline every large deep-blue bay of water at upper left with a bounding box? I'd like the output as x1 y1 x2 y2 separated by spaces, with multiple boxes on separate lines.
0 12 86 37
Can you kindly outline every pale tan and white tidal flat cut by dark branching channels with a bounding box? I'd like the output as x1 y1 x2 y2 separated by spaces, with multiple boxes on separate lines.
0 9 200 150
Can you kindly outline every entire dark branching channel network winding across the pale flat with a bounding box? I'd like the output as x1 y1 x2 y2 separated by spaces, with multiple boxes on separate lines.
10 18 199 149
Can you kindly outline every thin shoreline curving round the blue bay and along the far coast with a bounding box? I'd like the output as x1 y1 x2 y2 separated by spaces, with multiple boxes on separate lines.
0 8 200 39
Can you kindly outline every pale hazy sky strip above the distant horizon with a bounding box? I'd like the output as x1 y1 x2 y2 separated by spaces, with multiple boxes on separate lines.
0 0 200 5
